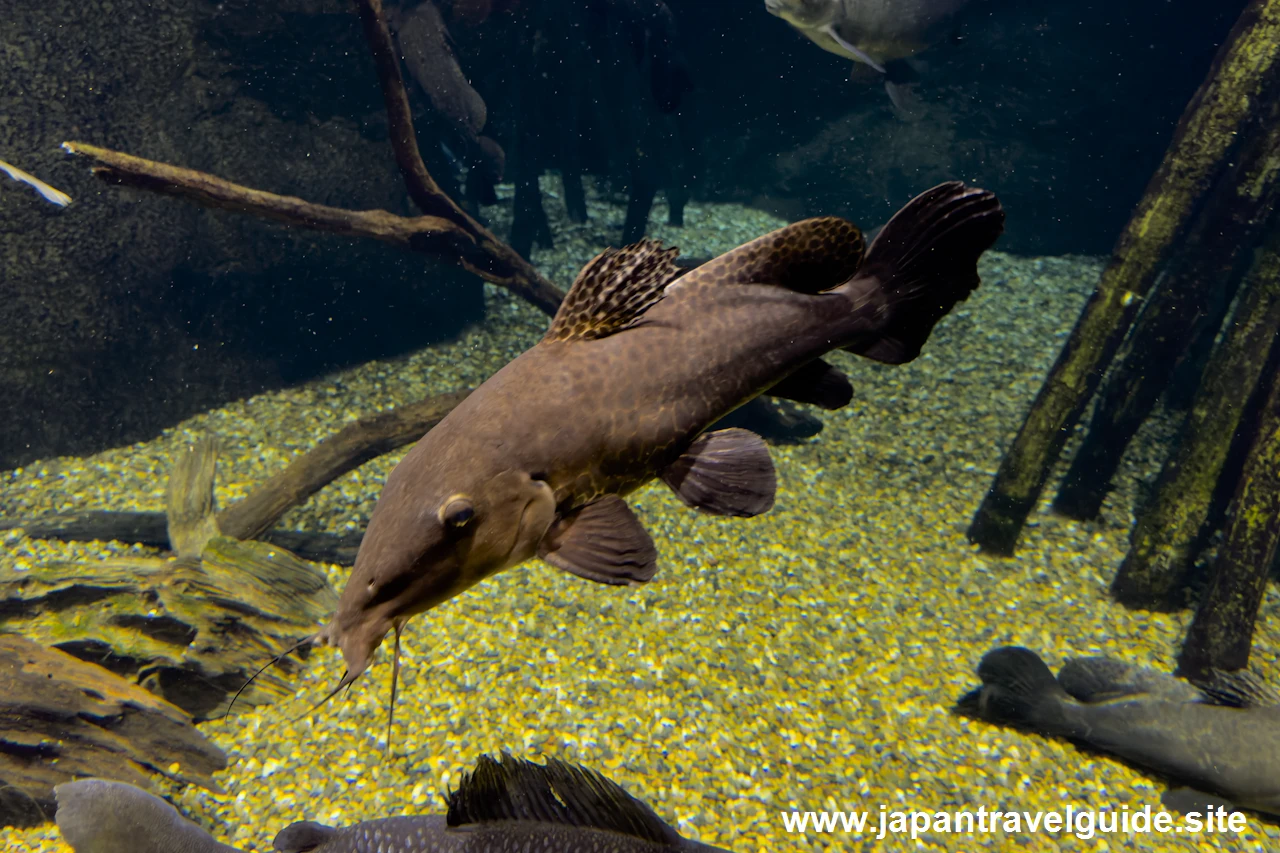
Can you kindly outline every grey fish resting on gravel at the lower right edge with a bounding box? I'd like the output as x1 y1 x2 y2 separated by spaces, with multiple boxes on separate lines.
956 646 1280 815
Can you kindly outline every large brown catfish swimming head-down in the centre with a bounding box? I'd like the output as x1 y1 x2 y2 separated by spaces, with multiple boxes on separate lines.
303 182 1005 697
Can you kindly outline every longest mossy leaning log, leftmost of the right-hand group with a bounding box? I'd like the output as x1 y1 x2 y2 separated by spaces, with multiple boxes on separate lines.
968 0 1280 555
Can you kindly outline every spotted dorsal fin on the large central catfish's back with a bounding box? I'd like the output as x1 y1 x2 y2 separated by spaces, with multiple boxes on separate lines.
543 240 684 341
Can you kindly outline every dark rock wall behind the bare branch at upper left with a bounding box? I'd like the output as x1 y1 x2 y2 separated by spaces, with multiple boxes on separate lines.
0 0 483 469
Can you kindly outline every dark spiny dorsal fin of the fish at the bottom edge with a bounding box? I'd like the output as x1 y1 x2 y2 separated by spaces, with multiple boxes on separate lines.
445 753 680 844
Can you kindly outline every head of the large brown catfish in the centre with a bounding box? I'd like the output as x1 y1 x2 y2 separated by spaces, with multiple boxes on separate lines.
315 441 556 689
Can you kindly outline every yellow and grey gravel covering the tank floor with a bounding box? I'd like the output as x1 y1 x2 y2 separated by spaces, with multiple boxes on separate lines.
0 180 1280 850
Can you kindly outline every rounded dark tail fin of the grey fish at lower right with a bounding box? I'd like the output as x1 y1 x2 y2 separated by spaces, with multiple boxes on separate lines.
956 646 1070 729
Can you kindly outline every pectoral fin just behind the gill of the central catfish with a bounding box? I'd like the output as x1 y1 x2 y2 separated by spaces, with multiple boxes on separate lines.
538 494 658 585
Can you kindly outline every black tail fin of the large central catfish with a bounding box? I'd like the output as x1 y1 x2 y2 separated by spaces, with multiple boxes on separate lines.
845 181 1005 364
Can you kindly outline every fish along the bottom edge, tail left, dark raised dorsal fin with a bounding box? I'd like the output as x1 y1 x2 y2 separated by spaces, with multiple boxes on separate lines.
54 756 723 853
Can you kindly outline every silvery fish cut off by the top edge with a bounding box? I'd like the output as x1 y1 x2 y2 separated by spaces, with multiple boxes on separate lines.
764 0 970 118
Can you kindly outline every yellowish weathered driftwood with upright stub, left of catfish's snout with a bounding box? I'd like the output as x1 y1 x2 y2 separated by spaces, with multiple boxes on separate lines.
0 442 338 720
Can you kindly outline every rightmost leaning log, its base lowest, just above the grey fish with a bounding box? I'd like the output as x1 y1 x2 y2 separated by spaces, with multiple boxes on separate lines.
1179 348 1280 675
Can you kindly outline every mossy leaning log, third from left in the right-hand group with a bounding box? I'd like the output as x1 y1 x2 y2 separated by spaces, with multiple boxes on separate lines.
1111 229 1280 610
